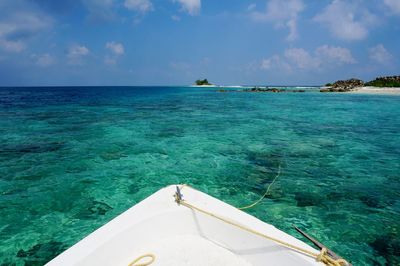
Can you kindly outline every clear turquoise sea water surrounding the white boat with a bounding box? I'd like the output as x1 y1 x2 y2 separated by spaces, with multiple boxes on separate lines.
0 87 400 265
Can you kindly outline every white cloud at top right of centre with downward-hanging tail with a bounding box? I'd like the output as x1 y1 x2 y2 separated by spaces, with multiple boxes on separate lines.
251 0 305 41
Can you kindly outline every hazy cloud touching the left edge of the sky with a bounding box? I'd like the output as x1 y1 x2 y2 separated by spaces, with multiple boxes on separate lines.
0 10 52 52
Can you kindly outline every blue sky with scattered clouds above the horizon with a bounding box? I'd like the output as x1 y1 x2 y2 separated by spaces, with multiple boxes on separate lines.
0 0 400 86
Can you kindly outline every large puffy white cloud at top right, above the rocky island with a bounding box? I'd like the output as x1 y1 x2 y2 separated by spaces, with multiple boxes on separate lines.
314 0 377 41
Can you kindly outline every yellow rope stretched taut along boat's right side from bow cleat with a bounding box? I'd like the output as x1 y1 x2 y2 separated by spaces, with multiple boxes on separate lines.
178 197 349 266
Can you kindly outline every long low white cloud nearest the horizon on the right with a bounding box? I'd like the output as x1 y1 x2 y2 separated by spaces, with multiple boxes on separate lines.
260 45 356 71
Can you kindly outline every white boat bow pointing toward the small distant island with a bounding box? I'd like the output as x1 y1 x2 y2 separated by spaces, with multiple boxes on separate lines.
47 186 323 266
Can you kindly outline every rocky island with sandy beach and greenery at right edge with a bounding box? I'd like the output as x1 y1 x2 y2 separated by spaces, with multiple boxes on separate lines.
320 76 400 92
